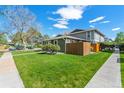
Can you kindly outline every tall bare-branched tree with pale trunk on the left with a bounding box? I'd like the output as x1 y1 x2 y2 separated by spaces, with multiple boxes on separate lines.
4 6 35 48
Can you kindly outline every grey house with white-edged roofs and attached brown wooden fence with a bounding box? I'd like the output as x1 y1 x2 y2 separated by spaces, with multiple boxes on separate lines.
43 29 105 55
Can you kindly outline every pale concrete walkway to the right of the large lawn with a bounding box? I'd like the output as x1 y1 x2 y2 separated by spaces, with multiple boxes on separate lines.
86 50 121 88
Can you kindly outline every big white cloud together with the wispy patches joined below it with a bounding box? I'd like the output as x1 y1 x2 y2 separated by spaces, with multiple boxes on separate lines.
48 5 86 29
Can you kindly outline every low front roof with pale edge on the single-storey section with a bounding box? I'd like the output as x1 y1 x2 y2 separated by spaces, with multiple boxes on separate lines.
44 35 87 41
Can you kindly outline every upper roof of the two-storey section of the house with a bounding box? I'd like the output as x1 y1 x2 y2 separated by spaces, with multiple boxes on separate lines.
69 28 105 36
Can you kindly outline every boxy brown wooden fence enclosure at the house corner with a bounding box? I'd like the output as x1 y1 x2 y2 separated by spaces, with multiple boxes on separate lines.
66 42 90 55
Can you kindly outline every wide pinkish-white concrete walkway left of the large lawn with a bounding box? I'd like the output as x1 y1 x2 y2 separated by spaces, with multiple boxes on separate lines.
0 52 24 88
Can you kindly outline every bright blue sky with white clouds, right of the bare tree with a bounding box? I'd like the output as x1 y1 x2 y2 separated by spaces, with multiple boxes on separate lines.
0 5 124 39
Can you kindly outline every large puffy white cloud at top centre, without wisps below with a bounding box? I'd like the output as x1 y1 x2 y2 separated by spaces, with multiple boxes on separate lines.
54 6 86 20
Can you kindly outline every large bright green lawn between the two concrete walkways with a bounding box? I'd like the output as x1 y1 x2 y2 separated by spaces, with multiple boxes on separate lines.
14 52 111 88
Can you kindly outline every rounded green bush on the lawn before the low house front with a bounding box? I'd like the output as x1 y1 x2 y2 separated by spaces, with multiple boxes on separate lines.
42 44 60 54
